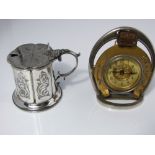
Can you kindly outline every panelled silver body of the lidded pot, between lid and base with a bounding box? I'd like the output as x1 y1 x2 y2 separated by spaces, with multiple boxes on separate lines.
13 64 56 105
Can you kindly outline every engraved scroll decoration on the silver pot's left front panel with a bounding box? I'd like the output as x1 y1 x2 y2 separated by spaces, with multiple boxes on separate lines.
16 72 30 99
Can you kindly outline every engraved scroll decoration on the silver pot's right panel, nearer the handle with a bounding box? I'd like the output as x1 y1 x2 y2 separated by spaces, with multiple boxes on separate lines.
37 71 49 99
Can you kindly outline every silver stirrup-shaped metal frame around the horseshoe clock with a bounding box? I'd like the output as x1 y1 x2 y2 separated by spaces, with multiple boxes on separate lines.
88 27 155 107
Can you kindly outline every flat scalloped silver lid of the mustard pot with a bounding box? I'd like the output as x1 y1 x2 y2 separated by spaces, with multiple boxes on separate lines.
7 44 52 69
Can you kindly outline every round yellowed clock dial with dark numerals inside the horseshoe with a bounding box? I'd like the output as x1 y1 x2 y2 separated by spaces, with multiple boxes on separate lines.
103 56 142 91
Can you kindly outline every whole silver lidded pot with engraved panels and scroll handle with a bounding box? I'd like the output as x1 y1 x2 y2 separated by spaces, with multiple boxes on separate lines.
7 44 79 111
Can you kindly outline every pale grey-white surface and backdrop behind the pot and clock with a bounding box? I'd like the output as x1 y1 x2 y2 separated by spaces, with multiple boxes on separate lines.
0 20 155 134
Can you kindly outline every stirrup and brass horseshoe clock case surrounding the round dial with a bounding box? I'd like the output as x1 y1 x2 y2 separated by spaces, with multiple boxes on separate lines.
89 27 155 107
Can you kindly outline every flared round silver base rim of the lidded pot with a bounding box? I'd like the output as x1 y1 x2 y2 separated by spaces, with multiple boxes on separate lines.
12 85 62 111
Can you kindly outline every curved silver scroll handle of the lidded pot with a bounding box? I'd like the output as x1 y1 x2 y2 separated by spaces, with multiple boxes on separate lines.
54 49 80 80
